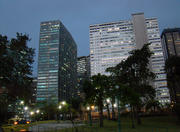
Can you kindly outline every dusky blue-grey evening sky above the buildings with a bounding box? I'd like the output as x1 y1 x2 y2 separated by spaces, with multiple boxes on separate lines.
0 0 180 76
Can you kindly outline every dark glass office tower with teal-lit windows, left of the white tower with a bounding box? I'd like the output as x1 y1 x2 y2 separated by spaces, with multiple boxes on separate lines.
37 20 77 103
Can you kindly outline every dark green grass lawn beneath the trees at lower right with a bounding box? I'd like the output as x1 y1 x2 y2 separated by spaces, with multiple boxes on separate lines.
58 116 180 132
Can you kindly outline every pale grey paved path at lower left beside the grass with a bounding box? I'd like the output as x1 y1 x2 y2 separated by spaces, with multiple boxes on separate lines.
29 123 83 132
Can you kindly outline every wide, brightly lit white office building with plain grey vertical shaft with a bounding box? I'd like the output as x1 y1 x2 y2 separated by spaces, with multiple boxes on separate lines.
90 13 170 103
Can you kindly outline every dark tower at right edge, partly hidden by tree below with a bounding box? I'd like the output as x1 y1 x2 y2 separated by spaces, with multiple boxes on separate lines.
161 28 180 59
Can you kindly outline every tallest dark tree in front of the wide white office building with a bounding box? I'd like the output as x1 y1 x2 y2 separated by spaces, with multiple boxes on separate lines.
107 44 155 126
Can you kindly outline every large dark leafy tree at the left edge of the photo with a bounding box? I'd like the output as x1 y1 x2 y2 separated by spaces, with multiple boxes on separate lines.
0 33 34 124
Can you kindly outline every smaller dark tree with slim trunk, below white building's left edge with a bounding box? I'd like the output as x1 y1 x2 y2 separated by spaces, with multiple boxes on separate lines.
83 74 108 127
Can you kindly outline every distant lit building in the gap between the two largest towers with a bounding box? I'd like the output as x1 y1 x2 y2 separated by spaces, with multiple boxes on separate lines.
77 56 90 96
